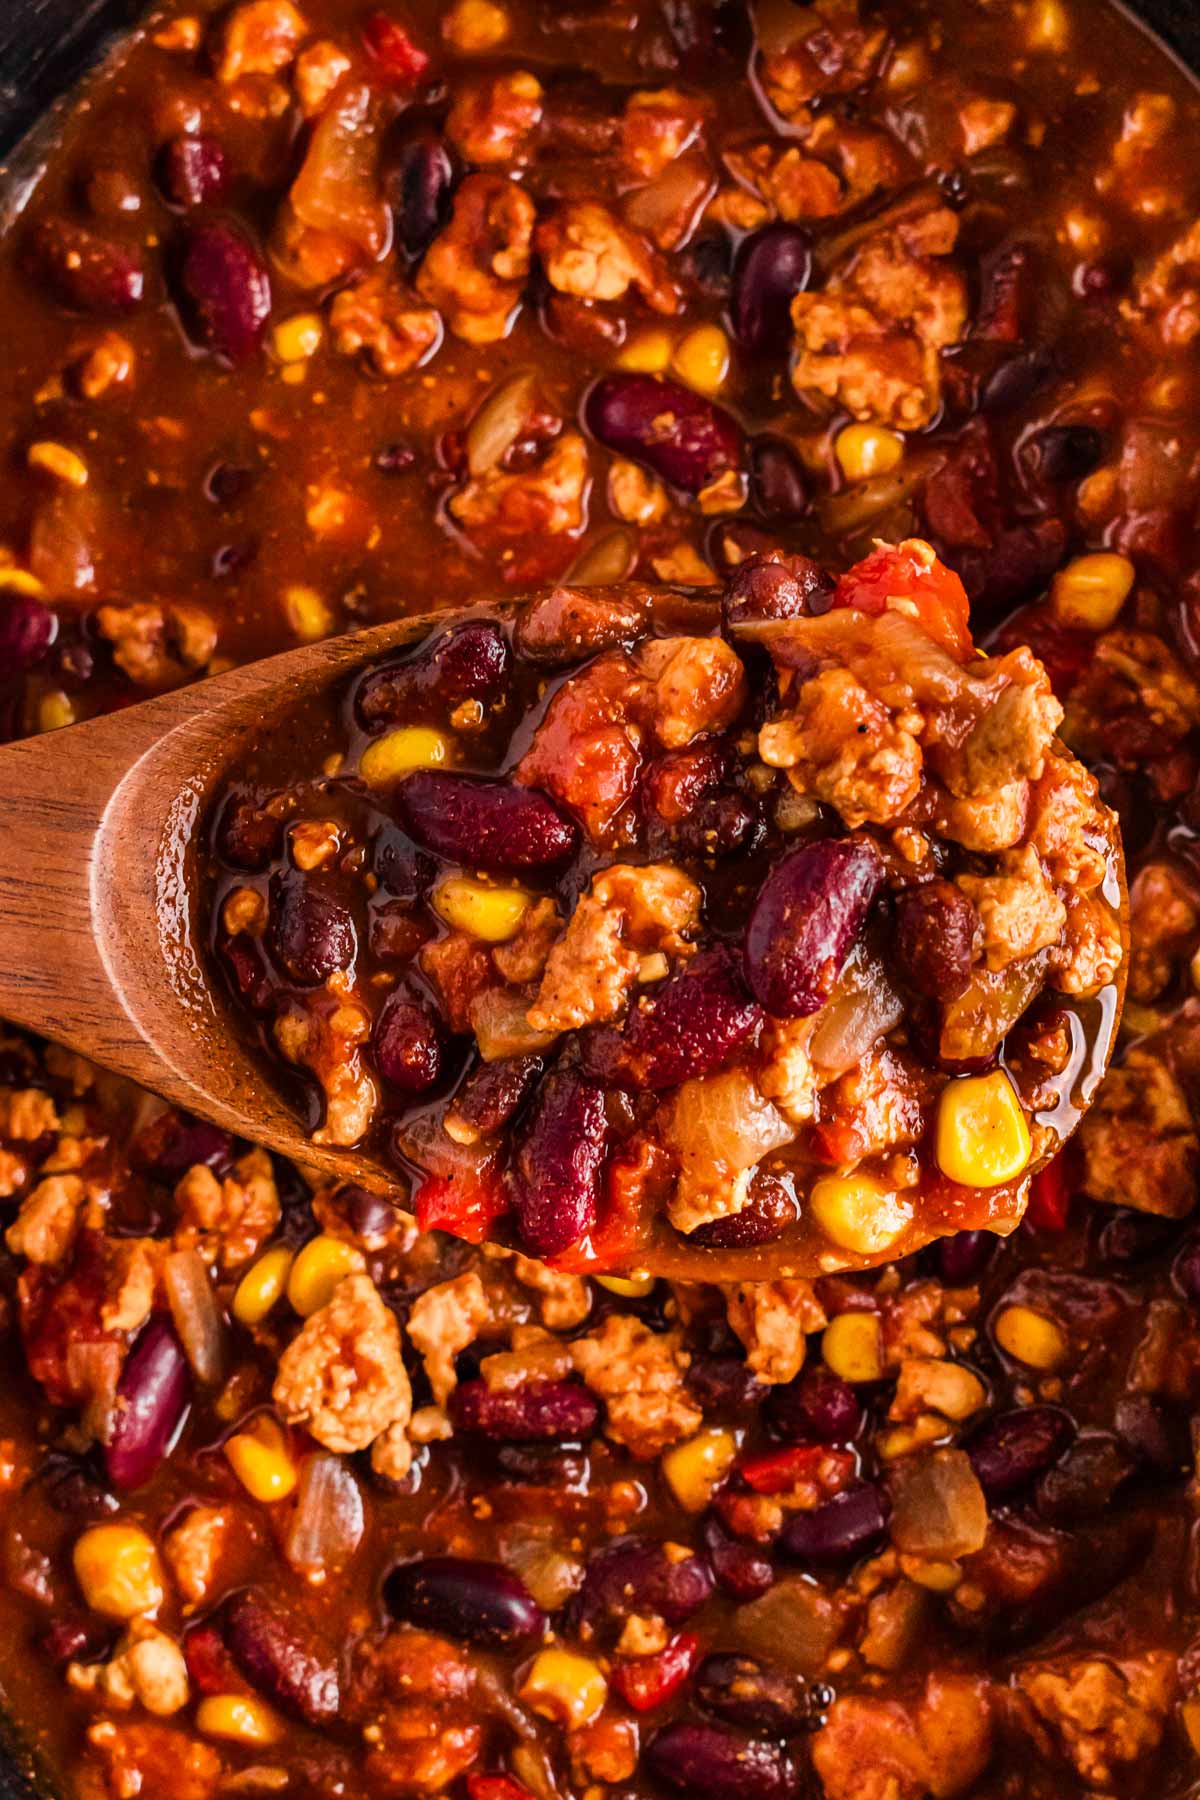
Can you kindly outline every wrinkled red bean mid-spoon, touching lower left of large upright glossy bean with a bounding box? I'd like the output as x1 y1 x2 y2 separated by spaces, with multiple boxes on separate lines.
624 945 763 1093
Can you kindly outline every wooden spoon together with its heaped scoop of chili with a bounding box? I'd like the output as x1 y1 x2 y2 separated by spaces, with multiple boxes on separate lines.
0 540 1128 1280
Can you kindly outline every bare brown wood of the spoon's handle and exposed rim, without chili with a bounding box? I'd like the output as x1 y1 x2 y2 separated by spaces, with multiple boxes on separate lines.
0 603 1128 1280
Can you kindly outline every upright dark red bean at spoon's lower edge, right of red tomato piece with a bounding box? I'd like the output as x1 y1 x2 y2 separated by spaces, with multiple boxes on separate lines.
511 1069 608 1256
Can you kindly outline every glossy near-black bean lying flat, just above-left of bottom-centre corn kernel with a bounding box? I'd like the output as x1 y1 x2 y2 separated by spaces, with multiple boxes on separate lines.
383 1557 545 1649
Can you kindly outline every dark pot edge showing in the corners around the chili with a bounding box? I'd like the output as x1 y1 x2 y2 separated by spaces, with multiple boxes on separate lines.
0 0 1200 1800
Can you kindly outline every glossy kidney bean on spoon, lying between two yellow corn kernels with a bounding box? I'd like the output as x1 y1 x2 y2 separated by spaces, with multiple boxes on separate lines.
394 770 579 869
